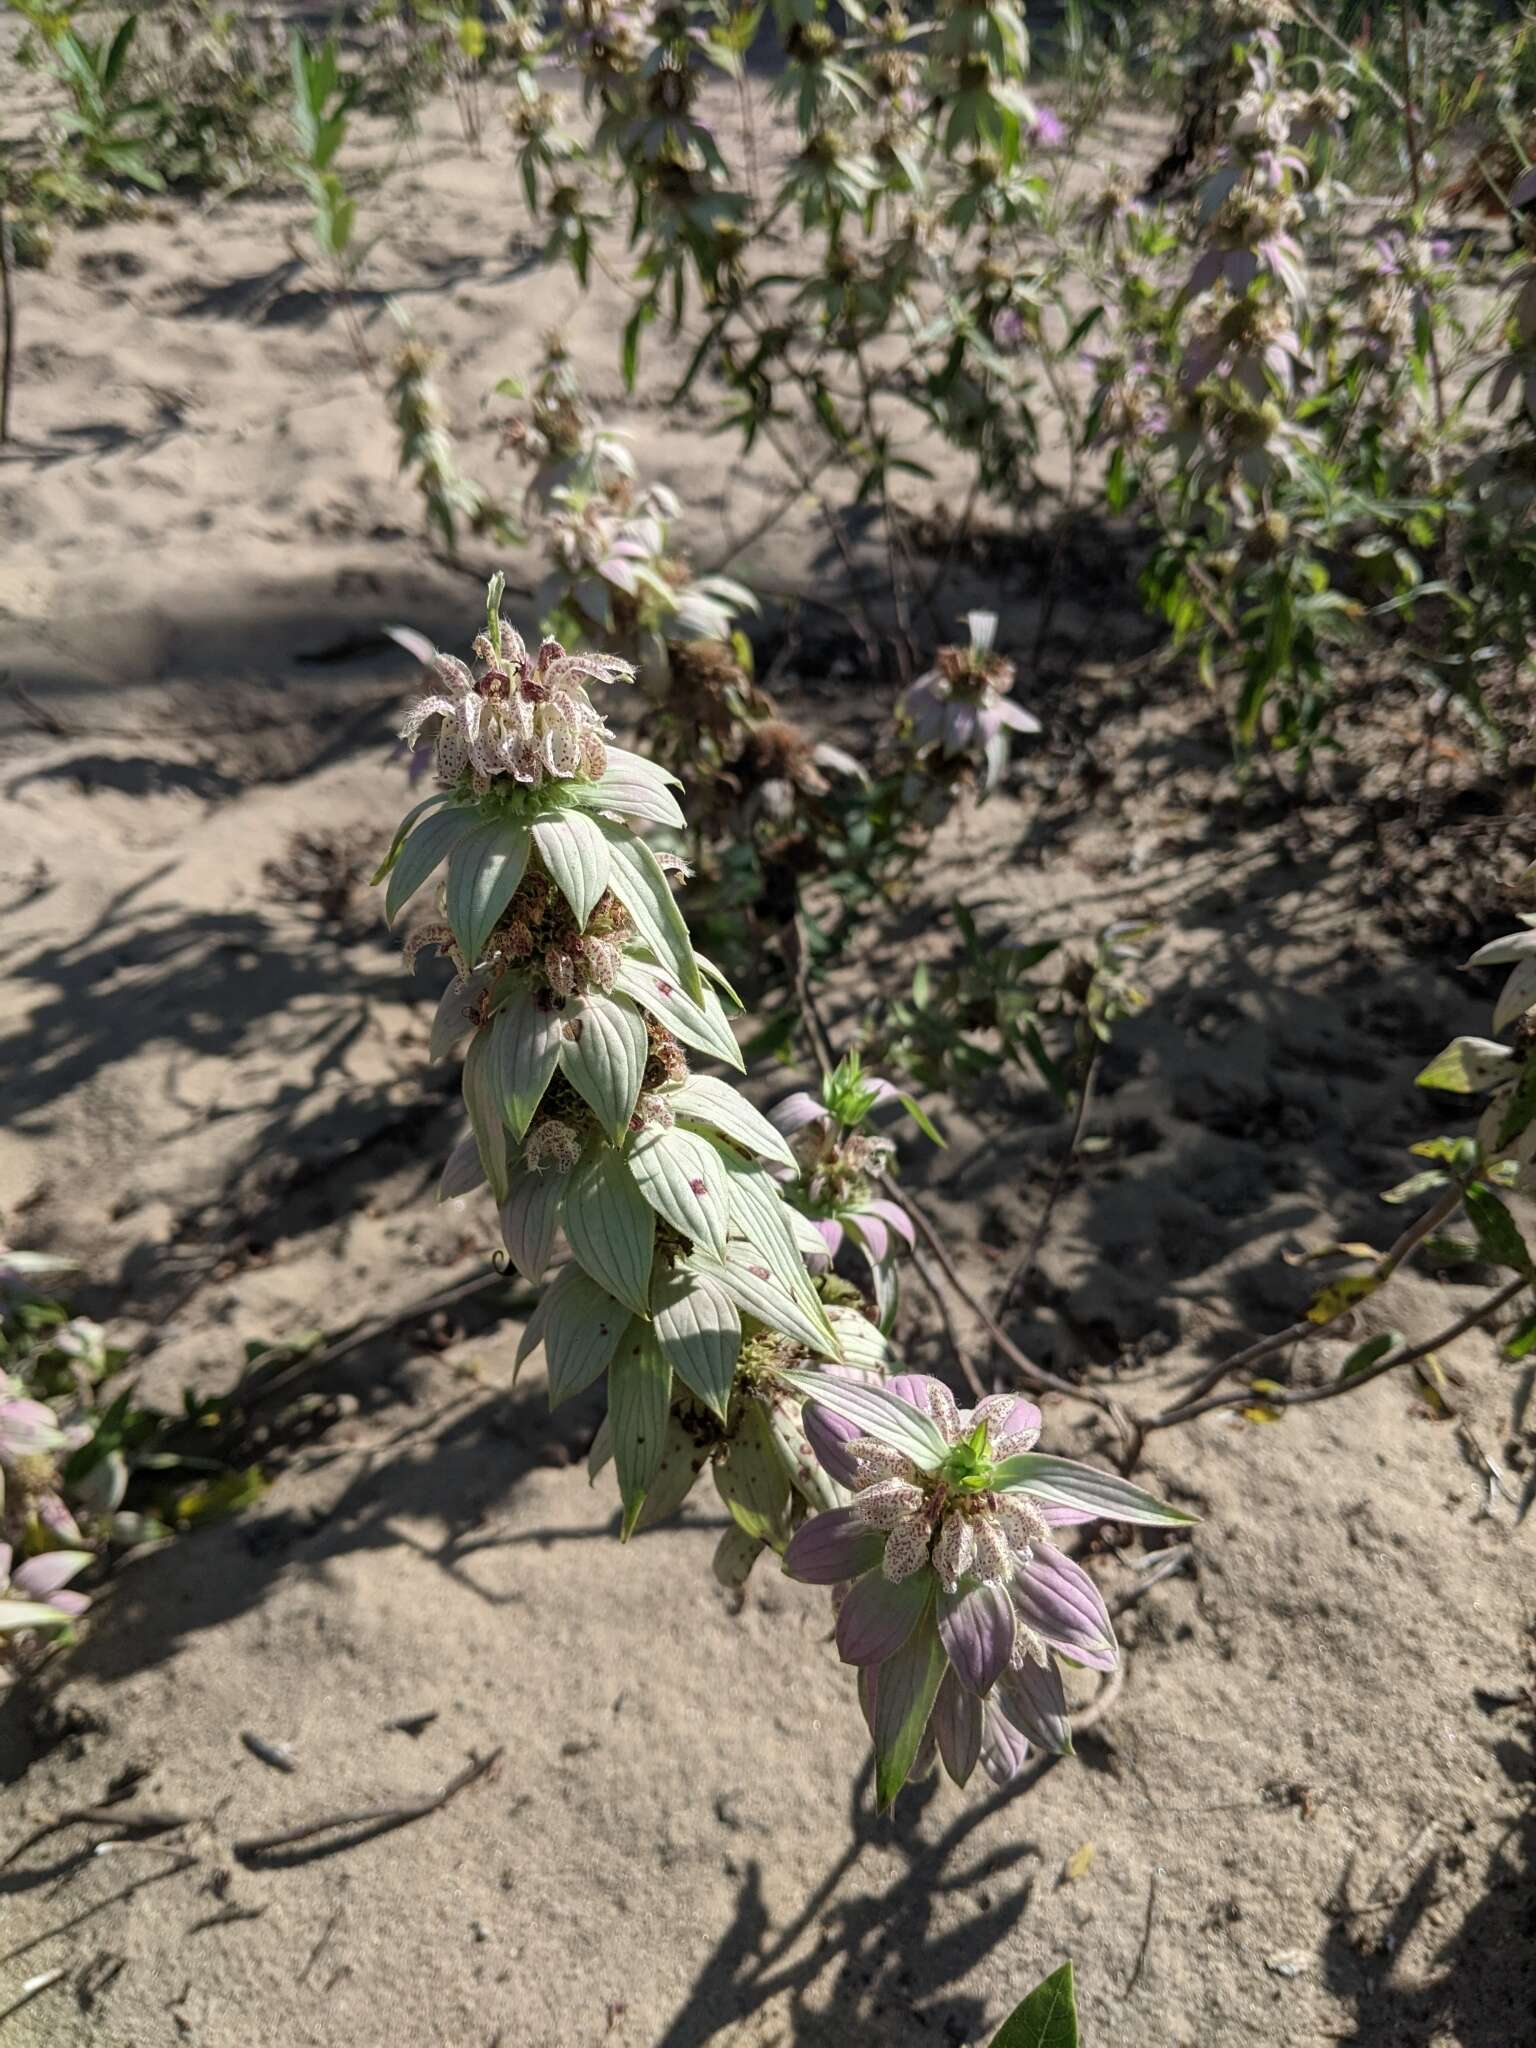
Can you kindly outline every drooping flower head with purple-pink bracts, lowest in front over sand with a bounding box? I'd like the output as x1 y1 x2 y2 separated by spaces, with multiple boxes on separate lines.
784 1372 1192 1810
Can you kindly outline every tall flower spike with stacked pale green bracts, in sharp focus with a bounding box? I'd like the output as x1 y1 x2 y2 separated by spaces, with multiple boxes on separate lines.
379 578 856 1546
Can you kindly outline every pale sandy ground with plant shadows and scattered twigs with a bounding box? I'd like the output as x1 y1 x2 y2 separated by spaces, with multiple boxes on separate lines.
0 32 1536 2048
